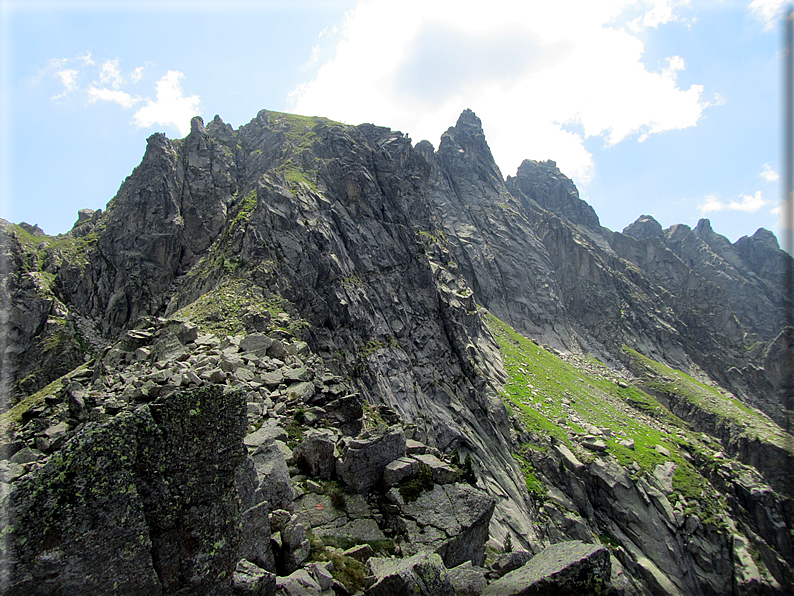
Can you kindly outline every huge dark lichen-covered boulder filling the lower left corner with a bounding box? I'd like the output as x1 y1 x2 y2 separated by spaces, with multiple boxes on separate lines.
0 387 247 596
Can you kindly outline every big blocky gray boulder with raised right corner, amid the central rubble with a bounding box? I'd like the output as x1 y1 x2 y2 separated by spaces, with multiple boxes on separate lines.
336 427 405 492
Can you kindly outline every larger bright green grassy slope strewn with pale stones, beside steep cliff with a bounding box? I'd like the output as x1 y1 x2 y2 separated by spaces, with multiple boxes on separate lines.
486 315 724 523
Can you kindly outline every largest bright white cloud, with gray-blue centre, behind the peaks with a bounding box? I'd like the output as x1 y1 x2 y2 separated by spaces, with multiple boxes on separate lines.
290 0 707 183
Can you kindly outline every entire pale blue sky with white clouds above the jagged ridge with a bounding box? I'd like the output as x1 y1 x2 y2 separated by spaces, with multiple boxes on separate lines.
0 0 782 241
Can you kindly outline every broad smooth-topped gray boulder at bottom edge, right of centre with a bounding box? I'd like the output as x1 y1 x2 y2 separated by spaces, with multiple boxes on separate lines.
483 540 612 596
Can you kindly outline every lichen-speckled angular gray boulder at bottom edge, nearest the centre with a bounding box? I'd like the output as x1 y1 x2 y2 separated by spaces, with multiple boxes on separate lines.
367 553 455 596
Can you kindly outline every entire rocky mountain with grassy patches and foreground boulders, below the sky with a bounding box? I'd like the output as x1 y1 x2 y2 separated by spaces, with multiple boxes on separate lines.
0 110 794 596
